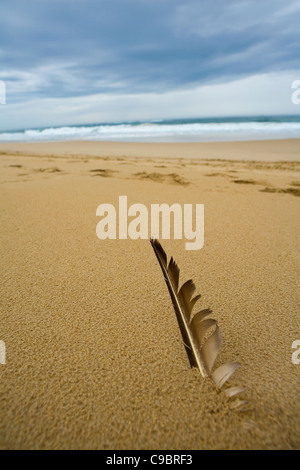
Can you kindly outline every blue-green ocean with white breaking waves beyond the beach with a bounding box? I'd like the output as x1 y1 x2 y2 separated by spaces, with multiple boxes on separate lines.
0 115 300 142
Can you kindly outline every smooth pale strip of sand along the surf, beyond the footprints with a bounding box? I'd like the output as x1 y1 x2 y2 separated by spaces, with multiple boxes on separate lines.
0 139 300 162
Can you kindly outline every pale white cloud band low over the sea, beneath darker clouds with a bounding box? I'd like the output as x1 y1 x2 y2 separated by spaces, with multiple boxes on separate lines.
0 70 300 131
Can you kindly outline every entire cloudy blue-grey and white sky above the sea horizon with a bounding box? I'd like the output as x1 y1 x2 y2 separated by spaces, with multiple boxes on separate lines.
0 0 300 131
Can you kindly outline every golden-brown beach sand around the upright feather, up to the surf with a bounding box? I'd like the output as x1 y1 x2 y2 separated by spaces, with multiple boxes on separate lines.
0 140 300 450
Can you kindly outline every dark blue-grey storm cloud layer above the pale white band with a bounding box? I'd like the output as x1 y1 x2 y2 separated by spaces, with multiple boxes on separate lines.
0 0 300 101
